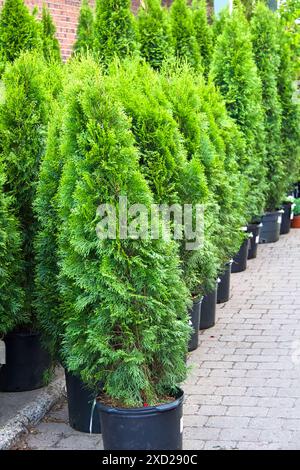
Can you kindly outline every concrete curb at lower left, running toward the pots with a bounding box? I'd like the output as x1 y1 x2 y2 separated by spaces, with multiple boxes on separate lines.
0 377 65 450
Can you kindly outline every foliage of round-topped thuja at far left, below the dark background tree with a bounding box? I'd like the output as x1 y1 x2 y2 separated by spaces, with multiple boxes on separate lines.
0 52 50 324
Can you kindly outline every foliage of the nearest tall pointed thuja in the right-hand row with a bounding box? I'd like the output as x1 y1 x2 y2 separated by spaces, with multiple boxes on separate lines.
211 8 266 219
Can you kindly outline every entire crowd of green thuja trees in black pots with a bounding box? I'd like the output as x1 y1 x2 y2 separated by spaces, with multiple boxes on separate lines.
0 0 299 449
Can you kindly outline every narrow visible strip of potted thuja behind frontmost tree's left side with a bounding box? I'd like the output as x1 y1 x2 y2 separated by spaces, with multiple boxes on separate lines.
34 100 101 434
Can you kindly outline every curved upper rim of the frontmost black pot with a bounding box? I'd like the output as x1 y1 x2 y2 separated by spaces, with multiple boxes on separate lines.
97 387 184 416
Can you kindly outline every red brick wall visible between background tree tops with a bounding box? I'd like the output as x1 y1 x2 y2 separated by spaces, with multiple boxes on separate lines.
0 0 140 59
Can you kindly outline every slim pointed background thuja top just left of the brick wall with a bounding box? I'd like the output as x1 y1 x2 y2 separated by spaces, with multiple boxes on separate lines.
41 4 61 62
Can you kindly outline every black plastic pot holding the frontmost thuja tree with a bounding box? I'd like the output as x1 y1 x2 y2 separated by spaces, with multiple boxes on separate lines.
97 390 184 450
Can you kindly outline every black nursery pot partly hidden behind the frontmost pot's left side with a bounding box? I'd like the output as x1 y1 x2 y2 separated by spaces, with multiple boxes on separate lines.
65 370 101 434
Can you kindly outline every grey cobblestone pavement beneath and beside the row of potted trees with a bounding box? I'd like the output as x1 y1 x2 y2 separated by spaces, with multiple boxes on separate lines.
12 230 300 450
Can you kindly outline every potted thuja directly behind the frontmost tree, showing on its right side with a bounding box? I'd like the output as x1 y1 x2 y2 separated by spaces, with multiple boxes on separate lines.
109 61 210 350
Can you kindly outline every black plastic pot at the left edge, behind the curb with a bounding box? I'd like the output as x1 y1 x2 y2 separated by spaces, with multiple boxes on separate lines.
0 332 51 392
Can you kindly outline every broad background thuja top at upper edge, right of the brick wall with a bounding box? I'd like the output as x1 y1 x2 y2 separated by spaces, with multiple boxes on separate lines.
94 0 137 65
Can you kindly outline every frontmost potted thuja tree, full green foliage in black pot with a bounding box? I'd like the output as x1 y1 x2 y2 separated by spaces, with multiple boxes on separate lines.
58 65 190 450
